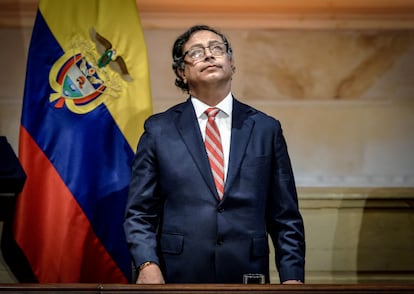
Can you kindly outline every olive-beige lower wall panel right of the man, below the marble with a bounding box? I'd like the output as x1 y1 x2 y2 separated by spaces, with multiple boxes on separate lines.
300 187 414 284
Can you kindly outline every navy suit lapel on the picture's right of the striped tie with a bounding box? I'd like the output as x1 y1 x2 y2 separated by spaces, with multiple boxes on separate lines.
224 99 254 198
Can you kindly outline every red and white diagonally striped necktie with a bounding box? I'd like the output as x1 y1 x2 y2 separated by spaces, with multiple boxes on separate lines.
204 107 224 200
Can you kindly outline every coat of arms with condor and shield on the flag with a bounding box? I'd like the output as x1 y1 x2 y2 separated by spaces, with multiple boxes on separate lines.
49 29 132 113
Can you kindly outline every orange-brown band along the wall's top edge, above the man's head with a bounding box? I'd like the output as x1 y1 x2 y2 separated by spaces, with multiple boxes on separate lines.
0 0 414 29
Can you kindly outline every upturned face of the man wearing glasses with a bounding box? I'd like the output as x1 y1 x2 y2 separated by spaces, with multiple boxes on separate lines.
182 31 233 91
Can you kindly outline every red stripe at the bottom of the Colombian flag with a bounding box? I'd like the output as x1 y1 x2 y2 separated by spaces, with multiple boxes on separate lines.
13 127 128 283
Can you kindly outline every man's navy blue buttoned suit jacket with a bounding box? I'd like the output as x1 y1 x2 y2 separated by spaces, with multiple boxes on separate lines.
124 99 305 283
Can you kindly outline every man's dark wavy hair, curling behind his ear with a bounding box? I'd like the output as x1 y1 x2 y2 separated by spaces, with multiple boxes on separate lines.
172 25 233 93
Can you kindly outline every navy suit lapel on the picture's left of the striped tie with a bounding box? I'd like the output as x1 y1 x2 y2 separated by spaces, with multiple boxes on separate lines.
175 99 218 197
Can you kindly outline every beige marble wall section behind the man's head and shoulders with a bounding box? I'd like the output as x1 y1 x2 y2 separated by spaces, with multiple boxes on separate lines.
146 30 414 187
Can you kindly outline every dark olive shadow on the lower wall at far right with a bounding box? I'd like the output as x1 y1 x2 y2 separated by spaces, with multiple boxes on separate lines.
356 199 414 283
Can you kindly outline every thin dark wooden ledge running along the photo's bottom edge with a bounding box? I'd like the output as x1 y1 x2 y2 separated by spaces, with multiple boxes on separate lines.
0 284 414 294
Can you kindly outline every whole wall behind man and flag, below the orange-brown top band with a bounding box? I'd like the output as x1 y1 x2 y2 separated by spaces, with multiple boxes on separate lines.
0 1 414 283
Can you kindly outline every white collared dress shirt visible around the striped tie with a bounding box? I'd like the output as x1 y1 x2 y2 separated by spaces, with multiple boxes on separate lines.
191 92 233 181
